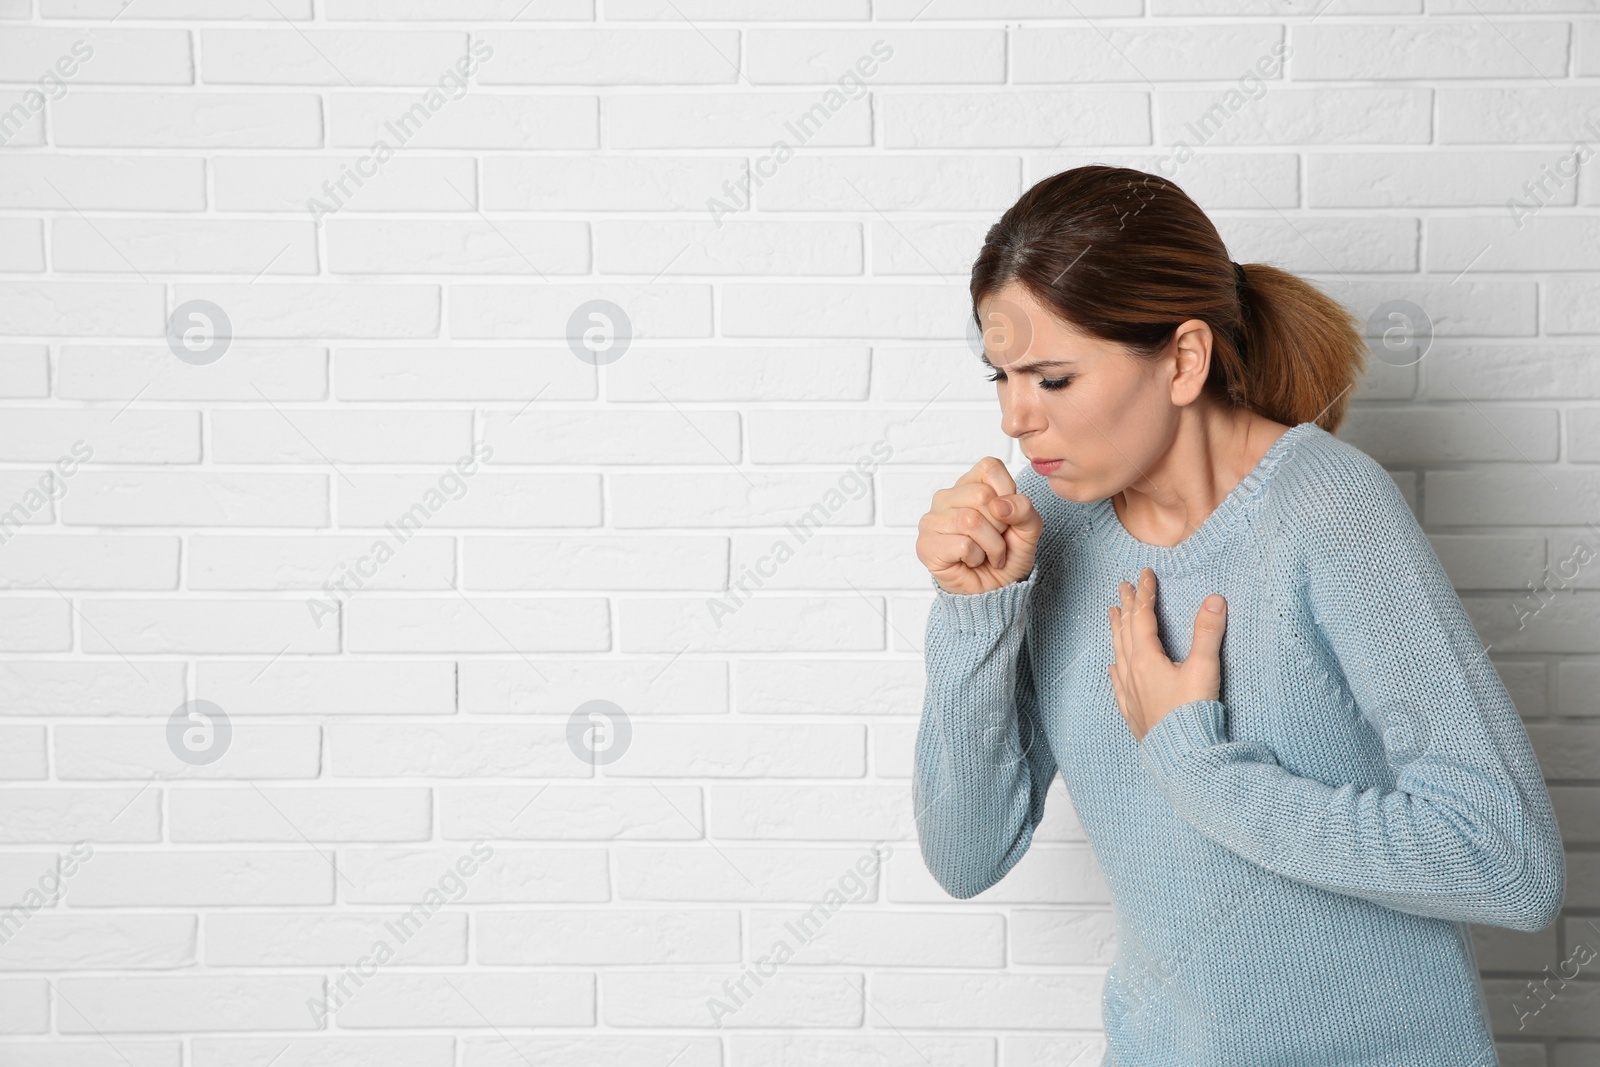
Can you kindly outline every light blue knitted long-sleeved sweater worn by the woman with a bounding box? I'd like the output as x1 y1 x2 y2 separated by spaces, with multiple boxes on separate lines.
914 422 1565 1067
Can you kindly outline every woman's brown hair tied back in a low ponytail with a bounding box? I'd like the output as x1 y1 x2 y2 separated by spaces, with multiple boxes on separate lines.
971 165 1366 434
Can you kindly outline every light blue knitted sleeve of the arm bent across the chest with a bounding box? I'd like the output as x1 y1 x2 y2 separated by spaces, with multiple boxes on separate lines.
1141 461 1566 931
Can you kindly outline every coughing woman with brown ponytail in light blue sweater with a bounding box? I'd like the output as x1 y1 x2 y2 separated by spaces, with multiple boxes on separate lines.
915 166 1565 1067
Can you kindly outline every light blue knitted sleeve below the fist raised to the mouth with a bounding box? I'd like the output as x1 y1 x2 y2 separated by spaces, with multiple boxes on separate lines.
912 568 1056 899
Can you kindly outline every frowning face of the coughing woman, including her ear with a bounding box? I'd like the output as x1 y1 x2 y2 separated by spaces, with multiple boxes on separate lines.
978 283 1210 502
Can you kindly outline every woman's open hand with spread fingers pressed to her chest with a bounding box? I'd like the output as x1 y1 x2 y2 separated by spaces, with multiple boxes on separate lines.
1107 568 1227 741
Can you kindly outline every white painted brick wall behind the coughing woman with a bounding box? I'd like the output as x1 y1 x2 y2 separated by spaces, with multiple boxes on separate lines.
0 0 1600 1067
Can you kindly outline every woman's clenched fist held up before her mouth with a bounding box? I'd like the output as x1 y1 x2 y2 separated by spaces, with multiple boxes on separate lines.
917 456 1045 593
